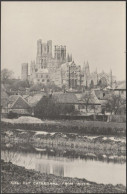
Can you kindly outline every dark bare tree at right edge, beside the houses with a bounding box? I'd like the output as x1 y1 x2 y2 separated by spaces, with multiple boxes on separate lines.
106 92 126 114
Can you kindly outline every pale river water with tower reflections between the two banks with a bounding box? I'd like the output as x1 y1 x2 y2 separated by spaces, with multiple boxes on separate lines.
1 151 126 185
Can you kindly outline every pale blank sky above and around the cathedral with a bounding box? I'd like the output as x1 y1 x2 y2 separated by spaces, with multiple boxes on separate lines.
1 1 126 80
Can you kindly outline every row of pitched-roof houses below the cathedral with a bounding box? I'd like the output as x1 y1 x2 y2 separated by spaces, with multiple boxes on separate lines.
1 81 126 117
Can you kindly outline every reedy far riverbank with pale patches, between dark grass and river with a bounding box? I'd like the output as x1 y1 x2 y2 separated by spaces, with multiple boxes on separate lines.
1 128 126 163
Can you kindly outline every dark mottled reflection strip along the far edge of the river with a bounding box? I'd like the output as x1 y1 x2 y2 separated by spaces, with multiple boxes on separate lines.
2 144 126 164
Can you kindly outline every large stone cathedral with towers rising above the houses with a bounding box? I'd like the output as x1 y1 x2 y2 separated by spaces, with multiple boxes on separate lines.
21 39 114 89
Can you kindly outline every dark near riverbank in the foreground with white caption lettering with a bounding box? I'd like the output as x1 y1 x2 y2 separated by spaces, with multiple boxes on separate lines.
1 161 126 193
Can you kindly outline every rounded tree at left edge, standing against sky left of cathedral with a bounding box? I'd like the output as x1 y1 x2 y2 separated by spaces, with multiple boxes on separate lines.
1 69 14 84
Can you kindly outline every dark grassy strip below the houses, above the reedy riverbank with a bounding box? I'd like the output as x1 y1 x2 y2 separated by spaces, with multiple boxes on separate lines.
1 120 126 136
